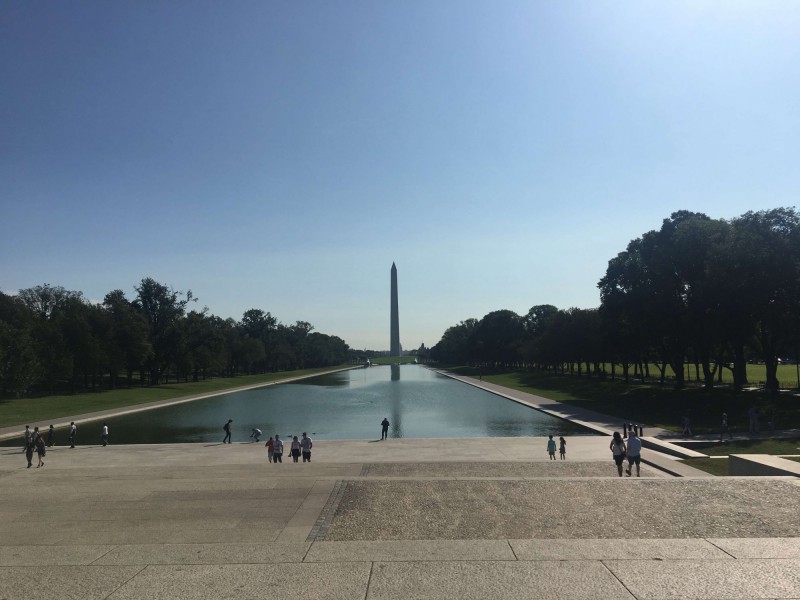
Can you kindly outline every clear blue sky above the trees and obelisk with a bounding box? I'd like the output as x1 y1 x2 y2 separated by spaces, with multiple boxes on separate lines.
0 0 800 349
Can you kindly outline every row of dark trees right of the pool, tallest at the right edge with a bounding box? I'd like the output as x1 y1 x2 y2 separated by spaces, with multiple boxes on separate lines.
431 208 800 392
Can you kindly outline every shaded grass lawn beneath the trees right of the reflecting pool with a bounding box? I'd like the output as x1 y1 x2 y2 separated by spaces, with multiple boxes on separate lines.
451 367 800 433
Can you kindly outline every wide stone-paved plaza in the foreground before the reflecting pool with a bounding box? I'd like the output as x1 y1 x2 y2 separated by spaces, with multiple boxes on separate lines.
0 437 800 600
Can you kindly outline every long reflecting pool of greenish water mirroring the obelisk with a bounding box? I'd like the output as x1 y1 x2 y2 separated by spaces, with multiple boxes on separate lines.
69 365 592 444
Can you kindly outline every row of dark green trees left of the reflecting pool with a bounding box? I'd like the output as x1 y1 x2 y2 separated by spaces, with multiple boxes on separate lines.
0 278 349 396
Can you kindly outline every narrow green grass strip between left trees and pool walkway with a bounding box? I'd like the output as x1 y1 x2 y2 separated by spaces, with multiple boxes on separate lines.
0 368 350 427
